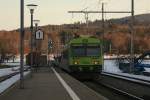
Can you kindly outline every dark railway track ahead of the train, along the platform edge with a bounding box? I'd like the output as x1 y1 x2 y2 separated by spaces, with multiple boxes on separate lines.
83 81 144 100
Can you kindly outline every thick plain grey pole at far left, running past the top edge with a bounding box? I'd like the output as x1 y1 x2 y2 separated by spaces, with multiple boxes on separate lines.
20 0 24 89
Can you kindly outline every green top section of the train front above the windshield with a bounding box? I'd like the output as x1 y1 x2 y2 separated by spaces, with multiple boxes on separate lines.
69 37 101 44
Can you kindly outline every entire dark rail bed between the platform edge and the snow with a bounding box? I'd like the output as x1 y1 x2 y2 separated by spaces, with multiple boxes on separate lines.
57 66 150 100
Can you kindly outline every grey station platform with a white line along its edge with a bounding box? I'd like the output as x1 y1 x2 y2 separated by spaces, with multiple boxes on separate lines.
0 68 107 100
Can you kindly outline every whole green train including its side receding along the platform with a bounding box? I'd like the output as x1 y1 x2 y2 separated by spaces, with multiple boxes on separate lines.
59 37 103 73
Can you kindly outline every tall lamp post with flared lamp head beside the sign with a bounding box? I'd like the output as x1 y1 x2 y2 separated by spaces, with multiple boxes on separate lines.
27 4 37 71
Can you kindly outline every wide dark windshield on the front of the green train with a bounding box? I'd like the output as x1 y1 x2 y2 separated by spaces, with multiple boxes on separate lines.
72 46 100 56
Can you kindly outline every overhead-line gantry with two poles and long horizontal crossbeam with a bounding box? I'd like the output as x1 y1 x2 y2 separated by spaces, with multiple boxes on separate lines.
68 0 134 72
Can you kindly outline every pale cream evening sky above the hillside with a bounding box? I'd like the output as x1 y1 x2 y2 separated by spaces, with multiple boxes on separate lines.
0 0 150 30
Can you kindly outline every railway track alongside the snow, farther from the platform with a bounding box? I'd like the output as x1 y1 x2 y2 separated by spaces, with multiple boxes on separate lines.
95 72 150 100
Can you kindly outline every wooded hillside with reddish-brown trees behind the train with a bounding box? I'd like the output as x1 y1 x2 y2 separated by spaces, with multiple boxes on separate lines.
0 14 150 54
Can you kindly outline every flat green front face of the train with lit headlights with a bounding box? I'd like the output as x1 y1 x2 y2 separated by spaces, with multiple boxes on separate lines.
69 38 102 73
